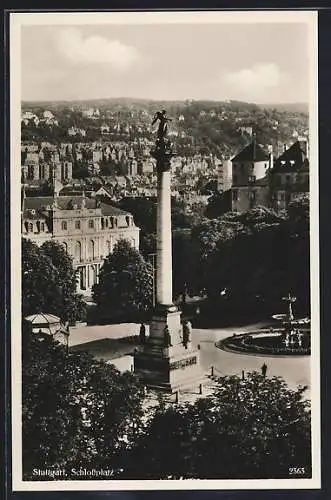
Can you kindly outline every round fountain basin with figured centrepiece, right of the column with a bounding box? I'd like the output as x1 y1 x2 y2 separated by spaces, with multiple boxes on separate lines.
216 293 310 356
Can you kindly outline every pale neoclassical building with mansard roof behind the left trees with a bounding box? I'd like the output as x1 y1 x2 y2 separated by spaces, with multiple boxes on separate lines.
22 196 140 294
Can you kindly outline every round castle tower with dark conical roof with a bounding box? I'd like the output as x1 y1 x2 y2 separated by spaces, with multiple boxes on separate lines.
231 138 270 212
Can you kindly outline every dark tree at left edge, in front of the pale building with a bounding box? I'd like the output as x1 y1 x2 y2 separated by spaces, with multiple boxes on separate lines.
22 238 85 322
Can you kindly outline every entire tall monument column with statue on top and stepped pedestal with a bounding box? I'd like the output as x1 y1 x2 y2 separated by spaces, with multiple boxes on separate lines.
134 112 202 392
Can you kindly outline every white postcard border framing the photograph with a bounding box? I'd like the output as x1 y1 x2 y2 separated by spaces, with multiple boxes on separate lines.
10 10 321 491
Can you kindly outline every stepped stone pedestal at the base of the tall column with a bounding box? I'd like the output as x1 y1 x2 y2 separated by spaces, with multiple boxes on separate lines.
134 306 203 392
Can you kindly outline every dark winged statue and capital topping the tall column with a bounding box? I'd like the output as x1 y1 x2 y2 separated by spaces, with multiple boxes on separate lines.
151 109 172 172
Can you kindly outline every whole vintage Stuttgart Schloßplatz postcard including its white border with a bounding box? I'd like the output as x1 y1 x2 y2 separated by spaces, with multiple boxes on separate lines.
10 10 321 491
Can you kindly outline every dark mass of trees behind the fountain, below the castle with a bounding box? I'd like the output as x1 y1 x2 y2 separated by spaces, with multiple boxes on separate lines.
192 198 310 318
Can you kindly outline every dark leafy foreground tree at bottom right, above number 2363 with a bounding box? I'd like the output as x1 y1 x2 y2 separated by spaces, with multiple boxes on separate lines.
125 372 311 479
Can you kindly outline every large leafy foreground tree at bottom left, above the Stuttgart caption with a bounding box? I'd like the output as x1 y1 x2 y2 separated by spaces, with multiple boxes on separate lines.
22 331 143 480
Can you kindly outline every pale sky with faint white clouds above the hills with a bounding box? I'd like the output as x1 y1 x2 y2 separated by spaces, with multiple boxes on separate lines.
21 23 309 103
